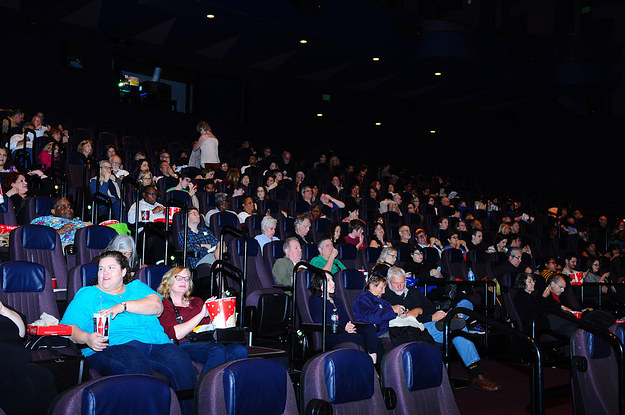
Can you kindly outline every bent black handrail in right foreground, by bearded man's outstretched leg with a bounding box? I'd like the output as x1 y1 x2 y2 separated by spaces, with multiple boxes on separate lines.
443 307 545 415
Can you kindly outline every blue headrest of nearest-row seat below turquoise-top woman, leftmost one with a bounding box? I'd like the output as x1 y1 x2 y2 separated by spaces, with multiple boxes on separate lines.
81 375 171 415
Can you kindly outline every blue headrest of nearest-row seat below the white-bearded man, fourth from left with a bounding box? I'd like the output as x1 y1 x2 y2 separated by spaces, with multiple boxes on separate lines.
401 343 443 392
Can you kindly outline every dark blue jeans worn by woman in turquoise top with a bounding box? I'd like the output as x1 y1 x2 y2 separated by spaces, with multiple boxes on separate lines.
87 340 196 414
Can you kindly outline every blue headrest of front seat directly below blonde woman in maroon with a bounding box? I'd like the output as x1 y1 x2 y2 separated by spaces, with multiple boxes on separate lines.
222 359 287 415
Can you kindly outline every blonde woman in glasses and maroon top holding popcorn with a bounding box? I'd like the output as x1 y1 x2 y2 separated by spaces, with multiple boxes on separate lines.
156 267 247 373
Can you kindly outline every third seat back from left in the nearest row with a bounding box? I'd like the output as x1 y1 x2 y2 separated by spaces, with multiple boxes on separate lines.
300 348 391 415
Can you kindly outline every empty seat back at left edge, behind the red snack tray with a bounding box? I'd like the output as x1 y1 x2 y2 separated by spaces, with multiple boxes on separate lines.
0 261 60 324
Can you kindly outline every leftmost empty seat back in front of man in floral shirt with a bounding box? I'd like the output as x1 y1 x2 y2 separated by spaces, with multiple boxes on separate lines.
9 225 67 299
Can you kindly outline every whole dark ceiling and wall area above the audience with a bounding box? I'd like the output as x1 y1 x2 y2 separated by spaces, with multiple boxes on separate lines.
0 0 625 215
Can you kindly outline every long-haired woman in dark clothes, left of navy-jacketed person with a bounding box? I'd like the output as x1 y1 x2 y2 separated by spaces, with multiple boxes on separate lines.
308 274 384 364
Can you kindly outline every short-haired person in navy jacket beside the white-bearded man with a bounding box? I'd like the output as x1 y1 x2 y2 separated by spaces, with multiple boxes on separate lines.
348 273 407 337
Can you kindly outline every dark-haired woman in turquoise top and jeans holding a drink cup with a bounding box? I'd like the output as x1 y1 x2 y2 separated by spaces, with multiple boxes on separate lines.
61 251 196 414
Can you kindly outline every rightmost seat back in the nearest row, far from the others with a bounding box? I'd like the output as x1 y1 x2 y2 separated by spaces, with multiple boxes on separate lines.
571 329 619 415
